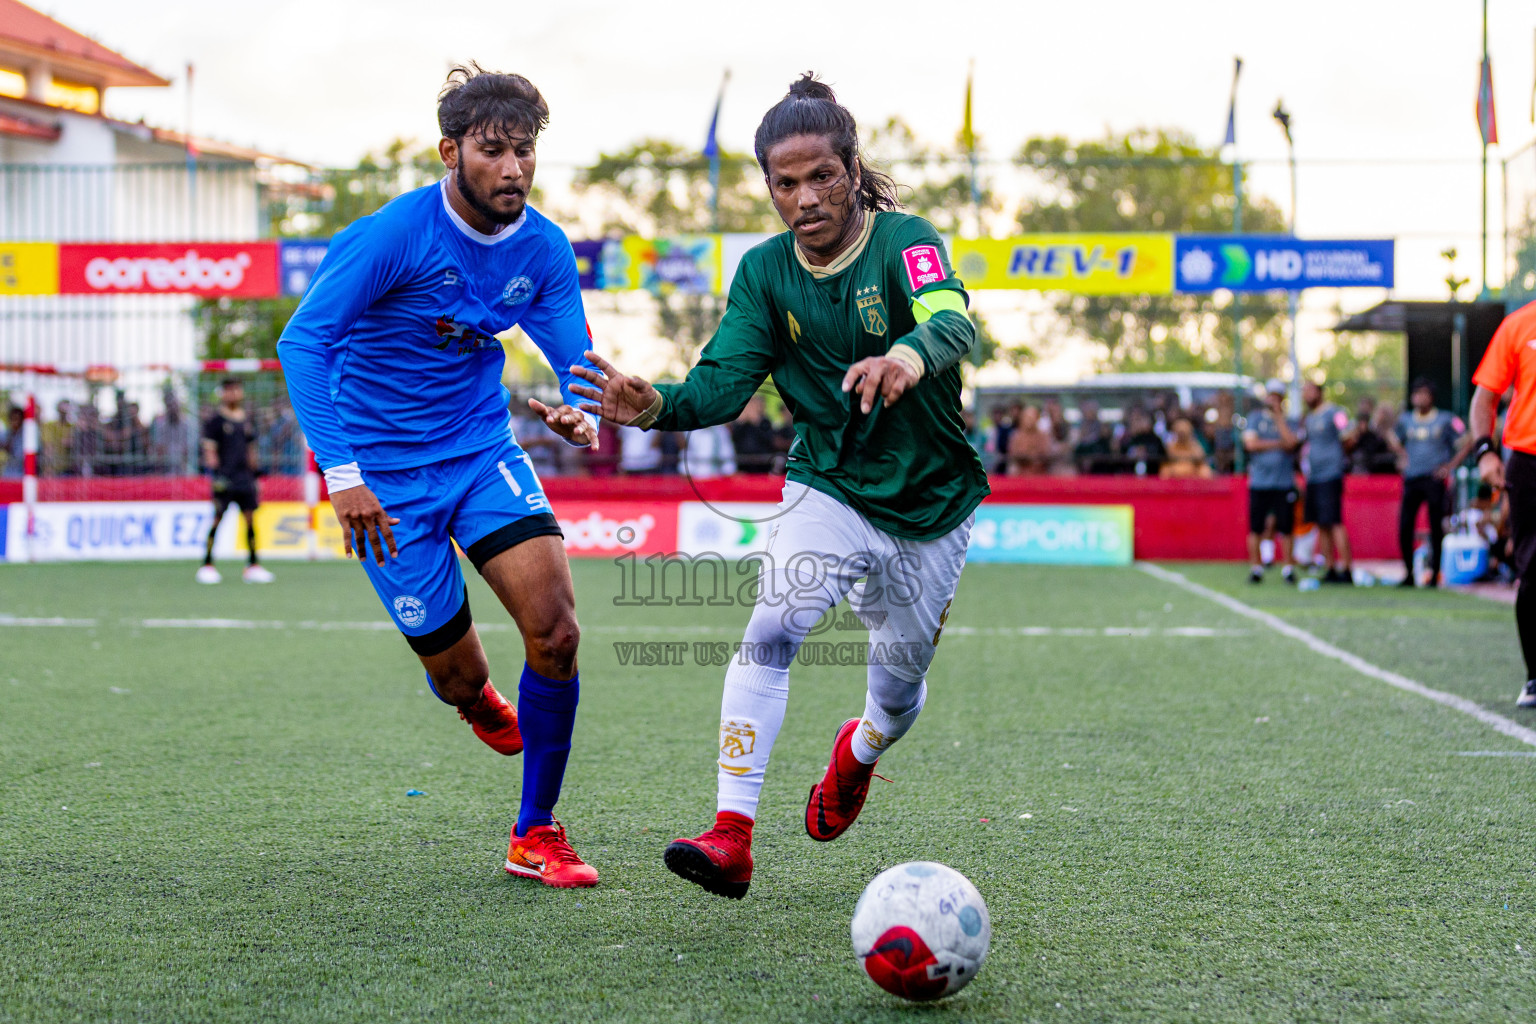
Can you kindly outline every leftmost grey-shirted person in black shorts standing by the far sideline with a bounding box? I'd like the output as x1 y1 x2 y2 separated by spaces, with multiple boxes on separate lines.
1243 381 1299 583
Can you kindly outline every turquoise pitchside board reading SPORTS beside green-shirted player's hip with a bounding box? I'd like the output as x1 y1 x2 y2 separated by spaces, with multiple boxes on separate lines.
966 502 1135 565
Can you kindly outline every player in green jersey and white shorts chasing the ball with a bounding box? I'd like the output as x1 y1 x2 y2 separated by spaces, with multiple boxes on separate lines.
573 75 988 898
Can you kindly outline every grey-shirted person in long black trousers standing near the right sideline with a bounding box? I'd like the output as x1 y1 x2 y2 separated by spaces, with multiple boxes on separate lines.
1389 378 1473 586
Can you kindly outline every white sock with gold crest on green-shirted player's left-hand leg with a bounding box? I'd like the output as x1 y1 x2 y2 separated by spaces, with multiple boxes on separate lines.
716 656 790 820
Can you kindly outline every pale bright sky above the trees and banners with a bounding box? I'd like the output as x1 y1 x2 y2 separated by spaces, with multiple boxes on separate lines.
34 0 1536 379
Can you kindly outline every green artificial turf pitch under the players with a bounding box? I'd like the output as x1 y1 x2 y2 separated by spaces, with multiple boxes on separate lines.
0 562 1536 1024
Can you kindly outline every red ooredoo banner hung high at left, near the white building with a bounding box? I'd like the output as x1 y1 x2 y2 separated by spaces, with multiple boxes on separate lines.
58 241 278 298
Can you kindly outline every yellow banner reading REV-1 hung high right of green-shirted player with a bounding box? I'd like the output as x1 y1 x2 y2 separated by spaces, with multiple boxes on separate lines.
951 233 1174 295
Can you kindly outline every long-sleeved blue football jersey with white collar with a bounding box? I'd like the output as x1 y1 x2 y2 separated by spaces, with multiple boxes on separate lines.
278 180 591 470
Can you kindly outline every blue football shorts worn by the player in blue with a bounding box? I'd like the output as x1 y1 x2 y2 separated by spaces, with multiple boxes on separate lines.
353 438 564 657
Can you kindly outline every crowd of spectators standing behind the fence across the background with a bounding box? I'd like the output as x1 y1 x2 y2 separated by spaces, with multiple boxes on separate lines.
0 368 1399 479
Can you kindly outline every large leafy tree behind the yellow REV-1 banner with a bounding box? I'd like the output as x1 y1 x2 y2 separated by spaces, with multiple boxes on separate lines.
1015 129 1286 376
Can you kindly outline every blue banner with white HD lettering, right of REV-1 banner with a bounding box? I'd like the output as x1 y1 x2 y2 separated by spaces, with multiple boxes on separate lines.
1175 235 1396 292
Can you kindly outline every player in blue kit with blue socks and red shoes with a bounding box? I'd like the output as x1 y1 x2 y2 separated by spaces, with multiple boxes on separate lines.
278 64 598 887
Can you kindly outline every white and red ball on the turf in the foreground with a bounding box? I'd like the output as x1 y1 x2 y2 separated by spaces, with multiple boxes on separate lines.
852 861 992 1001
